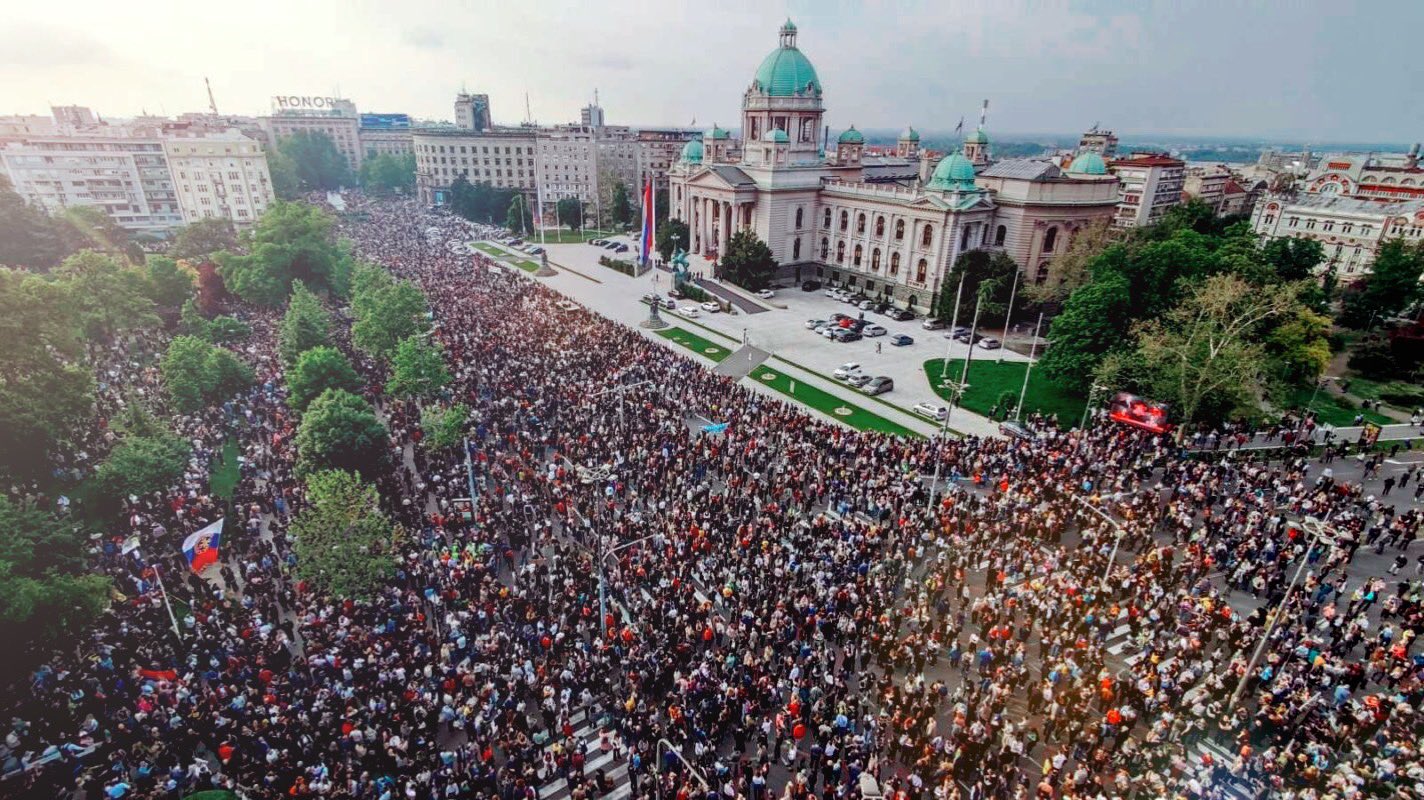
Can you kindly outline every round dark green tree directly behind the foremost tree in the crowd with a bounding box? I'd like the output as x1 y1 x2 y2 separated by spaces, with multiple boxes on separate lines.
296 389 390 478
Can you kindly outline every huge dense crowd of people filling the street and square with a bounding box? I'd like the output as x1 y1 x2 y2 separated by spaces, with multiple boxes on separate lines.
0 195 1424 800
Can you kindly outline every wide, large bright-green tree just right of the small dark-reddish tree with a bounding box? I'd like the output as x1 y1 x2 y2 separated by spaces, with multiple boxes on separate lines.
215 202 350 306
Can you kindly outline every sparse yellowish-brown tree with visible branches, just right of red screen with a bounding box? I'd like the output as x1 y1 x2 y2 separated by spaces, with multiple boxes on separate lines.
1136 275 1299 426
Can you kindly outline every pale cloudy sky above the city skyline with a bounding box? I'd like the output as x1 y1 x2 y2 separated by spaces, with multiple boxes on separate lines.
0 0 1424 142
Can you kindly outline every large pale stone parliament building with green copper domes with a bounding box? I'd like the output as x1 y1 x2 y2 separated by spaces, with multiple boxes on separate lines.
668 20 1118 313
